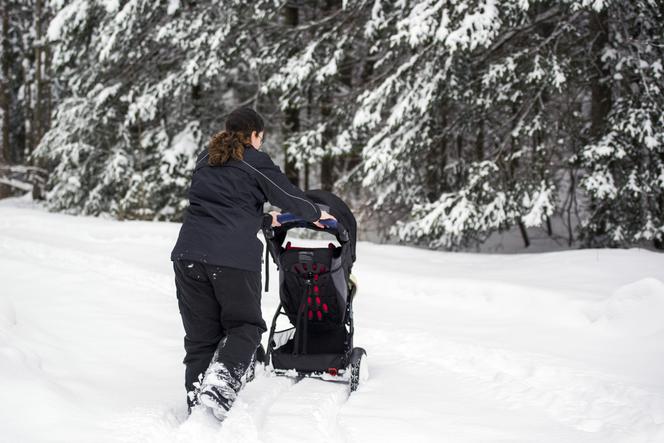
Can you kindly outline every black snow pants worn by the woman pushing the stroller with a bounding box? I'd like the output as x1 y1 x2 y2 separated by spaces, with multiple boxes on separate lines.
173 260 267 406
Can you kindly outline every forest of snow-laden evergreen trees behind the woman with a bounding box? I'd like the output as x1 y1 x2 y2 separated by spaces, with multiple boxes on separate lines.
0 0 664 250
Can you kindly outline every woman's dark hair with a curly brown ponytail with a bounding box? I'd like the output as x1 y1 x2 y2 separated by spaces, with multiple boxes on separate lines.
208 107 265 166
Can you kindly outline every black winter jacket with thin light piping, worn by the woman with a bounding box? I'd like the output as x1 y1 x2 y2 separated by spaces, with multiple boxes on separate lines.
171 145 321 272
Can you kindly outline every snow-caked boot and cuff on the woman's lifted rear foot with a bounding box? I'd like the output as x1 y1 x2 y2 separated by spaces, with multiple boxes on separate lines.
197 362 242 420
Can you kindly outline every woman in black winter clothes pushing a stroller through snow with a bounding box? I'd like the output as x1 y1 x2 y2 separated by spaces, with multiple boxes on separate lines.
171 108 334 418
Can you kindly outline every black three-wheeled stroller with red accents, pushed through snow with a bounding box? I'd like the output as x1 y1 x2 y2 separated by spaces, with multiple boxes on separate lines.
257 190 368 392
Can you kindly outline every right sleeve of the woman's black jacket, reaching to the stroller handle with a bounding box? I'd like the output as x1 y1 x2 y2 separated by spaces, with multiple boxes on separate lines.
242 151 321 222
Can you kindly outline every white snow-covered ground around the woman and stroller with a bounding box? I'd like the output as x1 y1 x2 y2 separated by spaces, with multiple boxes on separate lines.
0 199 664 443
